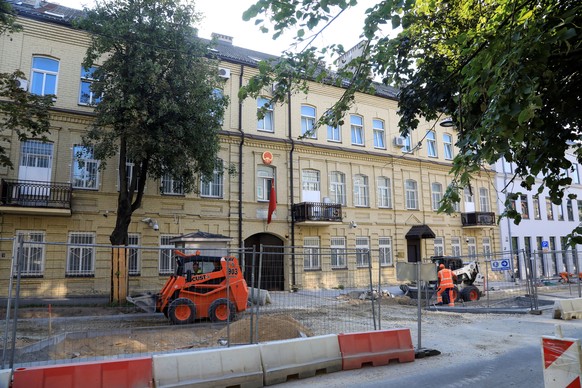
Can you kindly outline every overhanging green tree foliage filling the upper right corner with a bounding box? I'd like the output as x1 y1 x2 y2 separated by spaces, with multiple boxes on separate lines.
240 0 582 242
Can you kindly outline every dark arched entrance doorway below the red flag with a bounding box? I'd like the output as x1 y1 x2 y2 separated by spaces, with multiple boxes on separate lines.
245 233 285 291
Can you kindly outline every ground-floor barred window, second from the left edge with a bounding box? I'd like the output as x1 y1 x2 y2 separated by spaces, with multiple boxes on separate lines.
66 233 95 276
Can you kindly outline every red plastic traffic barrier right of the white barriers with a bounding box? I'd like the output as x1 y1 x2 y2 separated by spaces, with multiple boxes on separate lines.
338 329 414 370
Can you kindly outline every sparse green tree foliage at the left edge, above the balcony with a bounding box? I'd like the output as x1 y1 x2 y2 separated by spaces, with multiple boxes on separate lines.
0 0 53 167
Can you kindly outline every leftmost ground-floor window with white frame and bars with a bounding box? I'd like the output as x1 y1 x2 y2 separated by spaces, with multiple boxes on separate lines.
13 230 45 277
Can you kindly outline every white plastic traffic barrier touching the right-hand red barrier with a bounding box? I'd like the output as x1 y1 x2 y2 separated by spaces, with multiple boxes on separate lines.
259 334 342 385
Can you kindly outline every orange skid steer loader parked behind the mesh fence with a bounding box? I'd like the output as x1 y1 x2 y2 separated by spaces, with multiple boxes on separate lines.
155 250 249 325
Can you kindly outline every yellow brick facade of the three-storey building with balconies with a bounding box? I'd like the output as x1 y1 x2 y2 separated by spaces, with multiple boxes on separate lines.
0 5 500 297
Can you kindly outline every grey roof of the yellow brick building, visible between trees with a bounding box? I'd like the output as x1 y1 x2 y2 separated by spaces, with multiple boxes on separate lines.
7 0 398 100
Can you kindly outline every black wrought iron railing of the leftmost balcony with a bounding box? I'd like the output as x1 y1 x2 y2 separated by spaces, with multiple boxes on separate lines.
0 179 73 209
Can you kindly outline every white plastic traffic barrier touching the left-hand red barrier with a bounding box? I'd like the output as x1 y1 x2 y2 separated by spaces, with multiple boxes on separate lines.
153 345 263 388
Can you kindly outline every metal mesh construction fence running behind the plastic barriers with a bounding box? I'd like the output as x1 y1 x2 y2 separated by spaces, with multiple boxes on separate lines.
0 239 582 367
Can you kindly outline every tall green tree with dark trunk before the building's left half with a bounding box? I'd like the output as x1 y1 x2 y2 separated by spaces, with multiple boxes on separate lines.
78 0 227 245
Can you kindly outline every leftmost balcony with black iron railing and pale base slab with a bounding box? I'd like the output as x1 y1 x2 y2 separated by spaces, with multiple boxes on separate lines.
0 179 73 216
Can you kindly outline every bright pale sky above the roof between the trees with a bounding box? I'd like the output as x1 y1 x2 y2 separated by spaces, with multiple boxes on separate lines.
48 0 386 55
